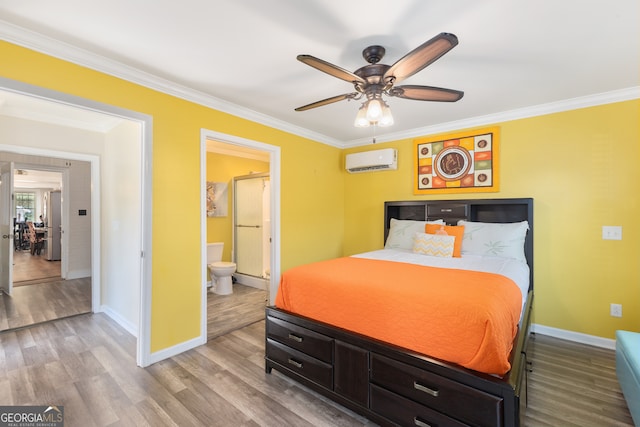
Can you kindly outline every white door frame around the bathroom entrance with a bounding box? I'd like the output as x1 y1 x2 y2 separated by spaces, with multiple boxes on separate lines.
200 128 280 342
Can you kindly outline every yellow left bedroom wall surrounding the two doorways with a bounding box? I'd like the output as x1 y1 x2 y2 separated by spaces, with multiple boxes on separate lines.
0 41 344 352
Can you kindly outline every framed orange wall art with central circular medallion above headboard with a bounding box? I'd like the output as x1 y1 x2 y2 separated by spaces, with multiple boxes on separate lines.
414 127 500 194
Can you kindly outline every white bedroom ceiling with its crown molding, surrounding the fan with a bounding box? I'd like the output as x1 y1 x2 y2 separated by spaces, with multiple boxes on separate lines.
0 0 640 147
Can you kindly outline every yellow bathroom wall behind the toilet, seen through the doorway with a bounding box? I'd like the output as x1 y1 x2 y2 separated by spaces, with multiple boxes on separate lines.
207 153 269 261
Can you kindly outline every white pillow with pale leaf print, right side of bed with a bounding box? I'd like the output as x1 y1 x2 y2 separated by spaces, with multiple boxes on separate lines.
458 220 529 262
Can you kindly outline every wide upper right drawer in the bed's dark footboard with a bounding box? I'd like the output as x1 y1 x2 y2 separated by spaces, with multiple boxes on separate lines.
370 353 503 426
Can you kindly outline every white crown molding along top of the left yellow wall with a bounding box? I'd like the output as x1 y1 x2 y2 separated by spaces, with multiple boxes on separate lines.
0 20 344 148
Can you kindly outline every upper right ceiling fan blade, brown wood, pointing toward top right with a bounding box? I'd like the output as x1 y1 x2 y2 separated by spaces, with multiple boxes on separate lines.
383 33 458 83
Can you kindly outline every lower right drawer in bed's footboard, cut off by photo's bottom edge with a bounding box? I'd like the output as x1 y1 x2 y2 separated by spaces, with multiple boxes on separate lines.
371 384 467 427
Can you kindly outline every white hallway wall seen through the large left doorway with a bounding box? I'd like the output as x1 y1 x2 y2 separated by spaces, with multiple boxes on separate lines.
0 116 142 335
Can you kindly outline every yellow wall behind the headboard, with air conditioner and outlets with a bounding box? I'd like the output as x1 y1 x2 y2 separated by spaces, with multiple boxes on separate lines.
344 100 640 338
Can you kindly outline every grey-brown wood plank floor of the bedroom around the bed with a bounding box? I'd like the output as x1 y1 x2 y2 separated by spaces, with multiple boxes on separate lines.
0 314 633 427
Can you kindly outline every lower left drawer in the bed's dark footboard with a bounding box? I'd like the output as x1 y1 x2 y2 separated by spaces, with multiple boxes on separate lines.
266 338 333 390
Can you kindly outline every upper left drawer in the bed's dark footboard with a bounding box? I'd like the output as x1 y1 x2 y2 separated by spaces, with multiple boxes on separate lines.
267 317 333 363
